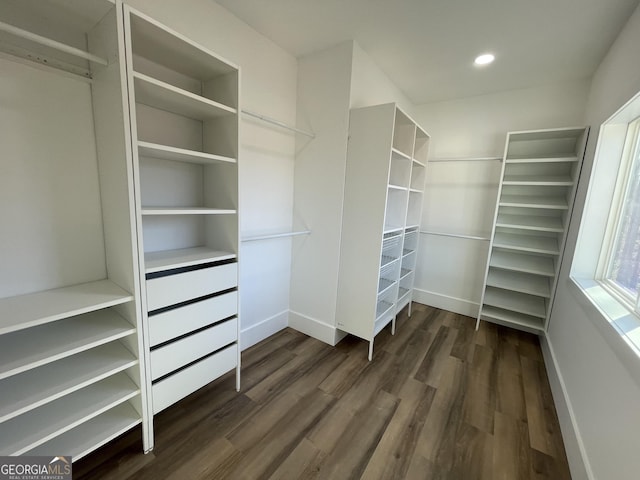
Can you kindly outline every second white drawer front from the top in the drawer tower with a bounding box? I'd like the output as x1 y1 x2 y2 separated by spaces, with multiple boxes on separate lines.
149 292 238 347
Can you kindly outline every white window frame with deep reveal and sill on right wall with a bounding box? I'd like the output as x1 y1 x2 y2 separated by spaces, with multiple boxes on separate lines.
572 88 640 378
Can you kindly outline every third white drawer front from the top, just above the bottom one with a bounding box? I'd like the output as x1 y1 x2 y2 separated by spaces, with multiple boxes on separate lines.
151 318 238 380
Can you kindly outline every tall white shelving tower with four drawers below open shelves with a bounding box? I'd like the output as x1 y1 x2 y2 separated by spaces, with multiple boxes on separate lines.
124 6 240 420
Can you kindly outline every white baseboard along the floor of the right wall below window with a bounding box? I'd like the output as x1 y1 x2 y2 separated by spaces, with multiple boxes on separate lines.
540 333 595 480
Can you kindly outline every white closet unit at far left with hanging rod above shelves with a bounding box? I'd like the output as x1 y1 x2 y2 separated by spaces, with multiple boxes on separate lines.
0 0 153 461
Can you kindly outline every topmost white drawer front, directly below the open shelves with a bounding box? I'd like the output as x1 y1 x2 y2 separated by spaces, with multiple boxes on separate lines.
147 263 238 311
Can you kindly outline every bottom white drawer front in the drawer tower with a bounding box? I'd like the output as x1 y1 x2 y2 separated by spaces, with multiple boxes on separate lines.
151 344 238 415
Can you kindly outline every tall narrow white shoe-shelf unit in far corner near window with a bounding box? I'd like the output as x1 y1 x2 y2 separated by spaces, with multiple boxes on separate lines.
478 128 588 333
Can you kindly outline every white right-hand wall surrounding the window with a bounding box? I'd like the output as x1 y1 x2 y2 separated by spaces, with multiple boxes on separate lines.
545 4 640 480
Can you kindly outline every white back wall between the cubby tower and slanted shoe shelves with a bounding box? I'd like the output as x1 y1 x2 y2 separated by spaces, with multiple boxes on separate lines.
414 80 589 316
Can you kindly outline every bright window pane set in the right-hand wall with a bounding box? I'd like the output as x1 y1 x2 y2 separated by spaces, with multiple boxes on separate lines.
598 119 640 311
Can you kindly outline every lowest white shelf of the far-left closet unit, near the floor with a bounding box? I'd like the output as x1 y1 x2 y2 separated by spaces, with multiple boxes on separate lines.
27 402 142 462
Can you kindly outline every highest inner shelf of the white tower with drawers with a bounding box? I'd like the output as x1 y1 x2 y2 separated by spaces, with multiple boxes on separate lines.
133 72 237 120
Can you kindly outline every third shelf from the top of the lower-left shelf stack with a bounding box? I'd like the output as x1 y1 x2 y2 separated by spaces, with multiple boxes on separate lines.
0 342 138 423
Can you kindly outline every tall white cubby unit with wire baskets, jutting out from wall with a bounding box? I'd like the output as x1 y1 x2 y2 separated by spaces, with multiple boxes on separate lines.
336 104 429 360
